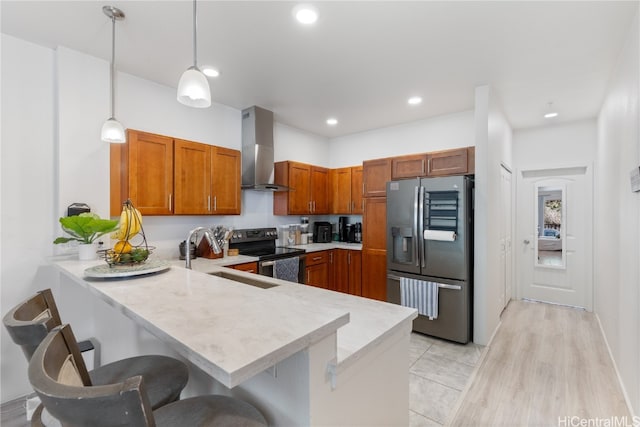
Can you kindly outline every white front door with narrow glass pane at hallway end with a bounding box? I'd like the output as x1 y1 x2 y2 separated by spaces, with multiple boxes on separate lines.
516 165 593 311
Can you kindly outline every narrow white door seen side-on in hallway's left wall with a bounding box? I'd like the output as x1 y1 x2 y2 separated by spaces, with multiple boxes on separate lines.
500 166 513 307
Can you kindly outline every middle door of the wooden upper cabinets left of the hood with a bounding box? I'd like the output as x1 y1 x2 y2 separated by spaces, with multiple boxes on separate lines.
174 139 212 215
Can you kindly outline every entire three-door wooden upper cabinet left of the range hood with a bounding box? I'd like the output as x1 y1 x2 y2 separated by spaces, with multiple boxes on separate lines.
110 129 241 216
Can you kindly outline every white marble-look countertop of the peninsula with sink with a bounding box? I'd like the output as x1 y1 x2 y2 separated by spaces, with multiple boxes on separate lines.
53 257 417 388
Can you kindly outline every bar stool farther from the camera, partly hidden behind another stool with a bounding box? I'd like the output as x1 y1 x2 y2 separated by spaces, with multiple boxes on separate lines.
3 289 189 409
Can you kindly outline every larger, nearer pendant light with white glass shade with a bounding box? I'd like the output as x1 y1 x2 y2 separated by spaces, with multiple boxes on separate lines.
178 0 211 108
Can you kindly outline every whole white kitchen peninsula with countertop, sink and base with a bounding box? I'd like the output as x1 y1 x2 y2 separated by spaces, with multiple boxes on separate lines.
53 259 416 426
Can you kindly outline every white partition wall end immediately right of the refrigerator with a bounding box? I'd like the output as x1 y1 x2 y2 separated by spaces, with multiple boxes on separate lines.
473 86 512 344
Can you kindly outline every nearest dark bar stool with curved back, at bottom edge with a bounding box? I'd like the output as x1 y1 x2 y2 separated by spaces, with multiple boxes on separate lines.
29 325 267 427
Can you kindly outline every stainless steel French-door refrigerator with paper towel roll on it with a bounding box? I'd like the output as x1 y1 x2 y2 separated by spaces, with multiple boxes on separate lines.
387 176 474 343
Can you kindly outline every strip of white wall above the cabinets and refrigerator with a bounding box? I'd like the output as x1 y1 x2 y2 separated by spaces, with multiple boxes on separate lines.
329 111 475 168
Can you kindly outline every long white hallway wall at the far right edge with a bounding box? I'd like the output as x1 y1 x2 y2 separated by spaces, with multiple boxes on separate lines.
594 9 640 414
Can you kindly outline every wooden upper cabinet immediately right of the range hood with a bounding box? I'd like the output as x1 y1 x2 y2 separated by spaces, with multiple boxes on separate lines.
273 161 331 215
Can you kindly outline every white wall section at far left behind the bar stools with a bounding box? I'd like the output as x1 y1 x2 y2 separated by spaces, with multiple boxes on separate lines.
0 35 57 402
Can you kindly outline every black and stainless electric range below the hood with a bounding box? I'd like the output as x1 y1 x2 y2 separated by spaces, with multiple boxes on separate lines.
229 227 306 283
